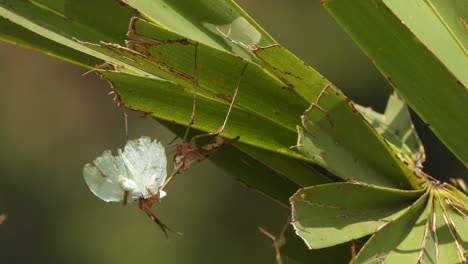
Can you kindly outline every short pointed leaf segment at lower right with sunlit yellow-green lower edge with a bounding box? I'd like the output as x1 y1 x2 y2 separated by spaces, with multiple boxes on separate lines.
290 183 422 249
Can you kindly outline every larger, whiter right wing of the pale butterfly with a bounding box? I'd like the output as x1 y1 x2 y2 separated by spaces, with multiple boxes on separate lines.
122 137 167 198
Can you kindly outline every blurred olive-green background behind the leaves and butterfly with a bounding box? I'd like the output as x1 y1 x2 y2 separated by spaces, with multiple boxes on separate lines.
0 0 467 264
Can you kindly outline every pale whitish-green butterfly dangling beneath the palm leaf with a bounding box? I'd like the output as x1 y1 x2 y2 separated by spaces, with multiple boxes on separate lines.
83 137 171 236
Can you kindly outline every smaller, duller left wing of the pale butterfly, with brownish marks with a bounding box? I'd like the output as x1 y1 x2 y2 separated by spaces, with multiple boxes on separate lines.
83 151 126 202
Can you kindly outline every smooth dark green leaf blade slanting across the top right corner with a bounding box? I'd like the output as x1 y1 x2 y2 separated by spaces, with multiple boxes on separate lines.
324 0 468 166
